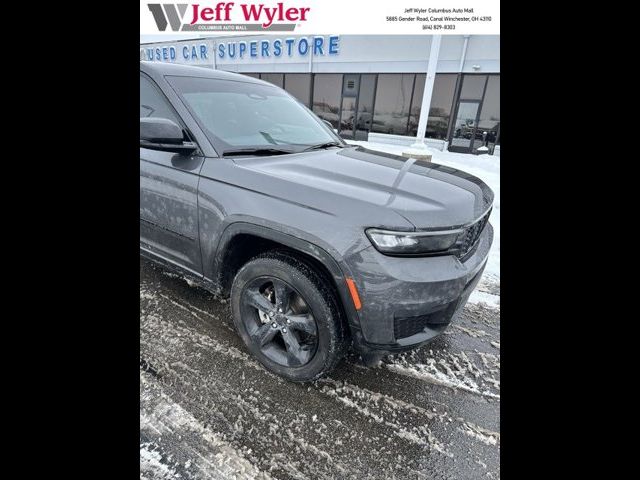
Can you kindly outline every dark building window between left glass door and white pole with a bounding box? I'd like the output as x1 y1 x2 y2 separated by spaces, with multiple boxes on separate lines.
371 73 415 135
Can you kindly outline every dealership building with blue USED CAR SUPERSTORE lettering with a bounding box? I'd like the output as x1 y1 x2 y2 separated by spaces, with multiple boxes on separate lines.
140 35 500 155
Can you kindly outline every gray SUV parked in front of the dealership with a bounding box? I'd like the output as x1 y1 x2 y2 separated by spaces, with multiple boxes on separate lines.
140 62 493 381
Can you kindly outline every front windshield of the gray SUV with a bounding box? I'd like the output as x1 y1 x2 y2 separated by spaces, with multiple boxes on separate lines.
167 77 343 154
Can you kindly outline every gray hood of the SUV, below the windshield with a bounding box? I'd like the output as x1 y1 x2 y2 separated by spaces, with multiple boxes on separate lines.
234 147 493 229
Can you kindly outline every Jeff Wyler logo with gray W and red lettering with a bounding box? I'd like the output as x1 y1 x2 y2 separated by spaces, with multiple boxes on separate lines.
148 2 311 32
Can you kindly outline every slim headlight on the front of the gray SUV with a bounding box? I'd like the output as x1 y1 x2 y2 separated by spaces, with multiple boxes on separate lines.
365 228 463 255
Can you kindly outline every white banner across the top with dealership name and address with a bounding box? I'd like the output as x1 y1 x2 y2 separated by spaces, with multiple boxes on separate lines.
140 0 500 37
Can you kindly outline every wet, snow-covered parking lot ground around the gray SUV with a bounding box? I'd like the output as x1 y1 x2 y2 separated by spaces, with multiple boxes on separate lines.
140 142 500 480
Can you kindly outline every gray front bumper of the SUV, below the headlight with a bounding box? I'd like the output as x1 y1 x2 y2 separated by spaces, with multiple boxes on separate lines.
347 224 493 353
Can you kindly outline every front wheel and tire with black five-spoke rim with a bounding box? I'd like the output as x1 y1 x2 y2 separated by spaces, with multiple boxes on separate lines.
231 251 347 382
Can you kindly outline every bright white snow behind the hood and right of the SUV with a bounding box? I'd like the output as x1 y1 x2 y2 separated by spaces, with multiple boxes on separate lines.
348 140 500 307
